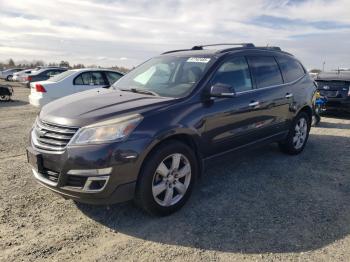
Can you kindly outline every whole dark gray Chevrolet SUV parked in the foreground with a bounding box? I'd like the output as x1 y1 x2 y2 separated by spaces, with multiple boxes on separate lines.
27 44 316 215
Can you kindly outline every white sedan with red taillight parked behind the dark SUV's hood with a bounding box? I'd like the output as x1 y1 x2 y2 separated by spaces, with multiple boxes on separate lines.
29 68 123 107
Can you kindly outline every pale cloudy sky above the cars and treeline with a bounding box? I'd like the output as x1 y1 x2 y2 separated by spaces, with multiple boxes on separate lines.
0 0 350 69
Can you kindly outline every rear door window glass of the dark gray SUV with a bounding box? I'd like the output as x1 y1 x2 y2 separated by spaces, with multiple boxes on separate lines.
248 56 283 88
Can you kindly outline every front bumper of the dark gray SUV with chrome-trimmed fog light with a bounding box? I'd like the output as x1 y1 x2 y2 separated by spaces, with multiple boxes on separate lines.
27 135 149 204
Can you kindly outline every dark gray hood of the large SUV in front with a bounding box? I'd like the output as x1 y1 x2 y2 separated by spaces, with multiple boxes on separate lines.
40 88 174 127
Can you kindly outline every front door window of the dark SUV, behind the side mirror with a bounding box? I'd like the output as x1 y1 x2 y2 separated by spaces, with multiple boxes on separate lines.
212 57 253 92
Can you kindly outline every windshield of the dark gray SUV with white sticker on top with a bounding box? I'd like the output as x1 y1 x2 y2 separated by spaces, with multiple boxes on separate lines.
112 56 213 98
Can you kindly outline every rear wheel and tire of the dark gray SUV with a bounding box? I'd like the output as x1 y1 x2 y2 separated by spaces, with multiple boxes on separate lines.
279 112 311 155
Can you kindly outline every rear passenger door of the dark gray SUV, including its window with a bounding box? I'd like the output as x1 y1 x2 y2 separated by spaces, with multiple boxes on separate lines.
247 55 292 137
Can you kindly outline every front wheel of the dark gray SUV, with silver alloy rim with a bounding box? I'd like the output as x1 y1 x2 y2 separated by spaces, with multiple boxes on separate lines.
134 140 198 216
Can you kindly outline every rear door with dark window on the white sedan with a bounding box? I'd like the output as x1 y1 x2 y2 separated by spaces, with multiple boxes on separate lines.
72 71 109 93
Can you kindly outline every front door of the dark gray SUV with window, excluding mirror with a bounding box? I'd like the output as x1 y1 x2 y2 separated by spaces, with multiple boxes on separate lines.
204 57 264 157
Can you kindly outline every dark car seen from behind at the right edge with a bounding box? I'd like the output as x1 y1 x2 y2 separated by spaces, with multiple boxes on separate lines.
315 70 350 112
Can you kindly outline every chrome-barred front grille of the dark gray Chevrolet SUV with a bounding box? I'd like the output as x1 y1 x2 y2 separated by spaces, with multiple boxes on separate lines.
32 119 78 152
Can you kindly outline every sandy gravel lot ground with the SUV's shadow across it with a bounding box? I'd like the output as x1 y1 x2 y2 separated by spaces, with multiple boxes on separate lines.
0 80 350 261
